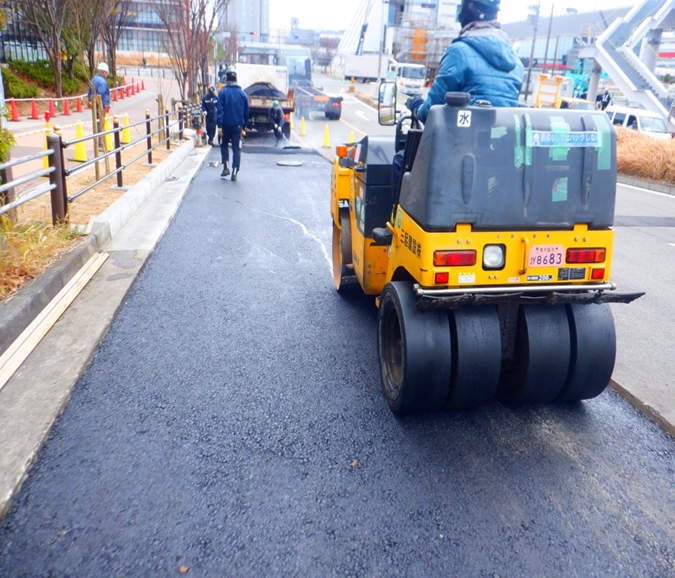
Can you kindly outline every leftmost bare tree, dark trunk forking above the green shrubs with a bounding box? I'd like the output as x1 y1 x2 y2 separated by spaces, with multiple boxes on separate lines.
16 0 68 97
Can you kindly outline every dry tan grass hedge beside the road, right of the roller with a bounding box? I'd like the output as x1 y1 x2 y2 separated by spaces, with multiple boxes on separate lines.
616 128 675 183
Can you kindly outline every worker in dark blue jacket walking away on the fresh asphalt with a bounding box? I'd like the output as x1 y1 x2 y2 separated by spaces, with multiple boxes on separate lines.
217 67 249 181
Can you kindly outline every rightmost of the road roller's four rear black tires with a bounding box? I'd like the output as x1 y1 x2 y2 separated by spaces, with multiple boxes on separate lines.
557 303 616 402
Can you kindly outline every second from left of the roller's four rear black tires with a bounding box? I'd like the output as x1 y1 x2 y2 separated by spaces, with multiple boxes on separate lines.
447 306 502 409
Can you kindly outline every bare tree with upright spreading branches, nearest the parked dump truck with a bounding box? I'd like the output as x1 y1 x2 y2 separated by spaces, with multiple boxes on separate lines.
152 0 229 100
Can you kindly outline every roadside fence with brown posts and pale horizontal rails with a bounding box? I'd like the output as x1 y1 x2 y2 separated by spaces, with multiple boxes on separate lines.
0 105 201 225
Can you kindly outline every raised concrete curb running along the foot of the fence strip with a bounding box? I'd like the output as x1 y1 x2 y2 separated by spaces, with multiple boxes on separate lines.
0 139 195 355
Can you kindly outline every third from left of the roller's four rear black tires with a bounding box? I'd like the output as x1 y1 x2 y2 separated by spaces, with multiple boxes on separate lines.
497 305 571 404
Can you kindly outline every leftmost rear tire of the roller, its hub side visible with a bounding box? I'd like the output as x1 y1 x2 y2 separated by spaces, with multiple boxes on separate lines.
377 281 452 416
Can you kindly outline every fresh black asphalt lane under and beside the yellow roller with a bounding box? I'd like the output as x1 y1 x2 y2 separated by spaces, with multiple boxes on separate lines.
0 144 675 577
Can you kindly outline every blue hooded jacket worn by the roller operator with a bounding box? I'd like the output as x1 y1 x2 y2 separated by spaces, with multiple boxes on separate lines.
417 22 525 122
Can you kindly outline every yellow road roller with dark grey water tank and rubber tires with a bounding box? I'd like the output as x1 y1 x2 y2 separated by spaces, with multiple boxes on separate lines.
330 88 643 415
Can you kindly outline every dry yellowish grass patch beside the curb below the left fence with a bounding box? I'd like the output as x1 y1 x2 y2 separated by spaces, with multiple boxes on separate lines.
0 215 77 301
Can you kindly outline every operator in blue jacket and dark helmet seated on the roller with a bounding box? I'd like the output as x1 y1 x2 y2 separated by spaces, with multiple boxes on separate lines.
392 0 525 195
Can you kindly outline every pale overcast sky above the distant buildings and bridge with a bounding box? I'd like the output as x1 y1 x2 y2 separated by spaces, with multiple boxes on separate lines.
270 0 634 30
